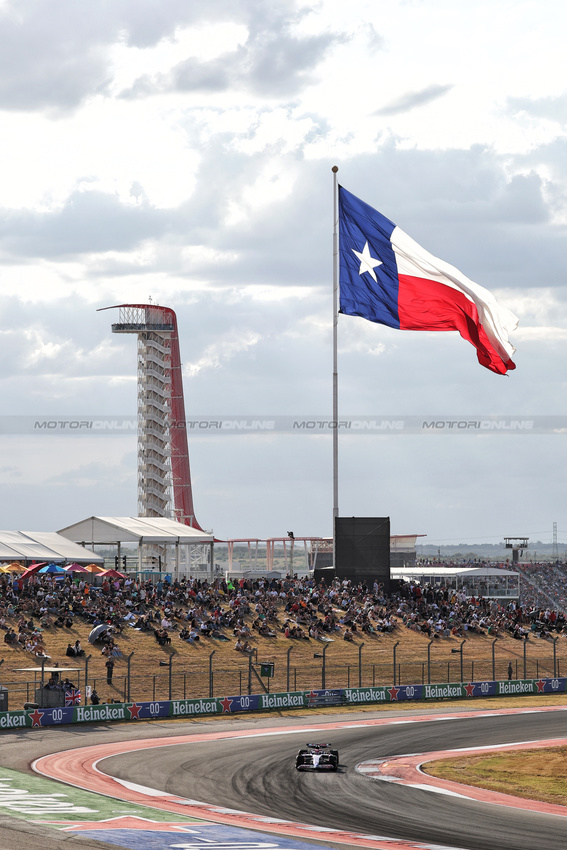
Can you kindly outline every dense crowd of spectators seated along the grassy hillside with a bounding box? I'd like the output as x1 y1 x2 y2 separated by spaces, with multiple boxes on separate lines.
0 565 567 659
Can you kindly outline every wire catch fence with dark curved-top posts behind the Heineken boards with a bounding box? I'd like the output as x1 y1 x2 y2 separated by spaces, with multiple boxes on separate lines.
0 638 565 711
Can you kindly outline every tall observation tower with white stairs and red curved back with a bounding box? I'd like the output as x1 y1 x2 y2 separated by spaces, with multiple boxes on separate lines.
102 304 204 531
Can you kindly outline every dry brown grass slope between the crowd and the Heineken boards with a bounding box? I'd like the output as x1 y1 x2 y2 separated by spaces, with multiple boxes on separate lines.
0 600 567 710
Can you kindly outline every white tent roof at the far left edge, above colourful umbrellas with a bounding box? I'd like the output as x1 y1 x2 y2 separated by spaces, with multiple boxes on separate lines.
0 531 104 564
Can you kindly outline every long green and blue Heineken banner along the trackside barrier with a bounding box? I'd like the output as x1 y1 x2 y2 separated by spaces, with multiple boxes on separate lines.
0 678 567 730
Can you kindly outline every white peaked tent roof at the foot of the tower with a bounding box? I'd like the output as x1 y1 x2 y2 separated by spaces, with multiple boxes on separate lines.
59 516 214 544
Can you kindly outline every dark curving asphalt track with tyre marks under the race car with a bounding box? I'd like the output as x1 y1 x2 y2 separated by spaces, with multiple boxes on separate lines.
99 711 567 850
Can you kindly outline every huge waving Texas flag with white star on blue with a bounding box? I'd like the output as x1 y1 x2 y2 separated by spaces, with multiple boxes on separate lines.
339 186 518 375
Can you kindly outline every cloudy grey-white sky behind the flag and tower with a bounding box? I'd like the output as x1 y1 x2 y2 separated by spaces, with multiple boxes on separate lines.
0 0 567 543
